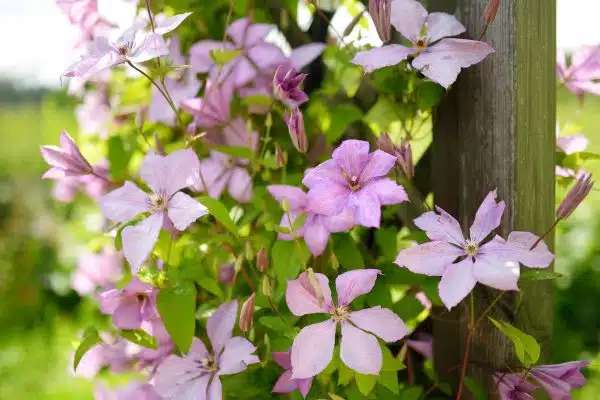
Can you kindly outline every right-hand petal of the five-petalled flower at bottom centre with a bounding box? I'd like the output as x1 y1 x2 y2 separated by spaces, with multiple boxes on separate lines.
349 306 410 342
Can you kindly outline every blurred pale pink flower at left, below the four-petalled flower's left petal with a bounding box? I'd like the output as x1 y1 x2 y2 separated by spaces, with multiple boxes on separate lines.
71 247 122 296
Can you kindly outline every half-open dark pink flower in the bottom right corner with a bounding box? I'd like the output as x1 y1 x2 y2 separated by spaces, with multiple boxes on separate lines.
531 361 590 400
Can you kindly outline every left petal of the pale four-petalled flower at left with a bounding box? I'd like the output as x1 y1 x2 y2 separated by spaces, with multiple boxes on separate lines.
98 181 152 222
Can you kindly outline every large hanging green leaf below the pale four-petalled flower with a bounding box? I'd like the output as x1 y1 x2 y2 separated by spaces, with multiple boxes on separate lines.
156 281 196 353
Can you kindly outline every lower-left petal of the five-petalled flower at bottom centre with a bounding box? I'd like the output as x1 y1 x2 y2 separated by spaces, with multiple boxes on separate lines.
292 319 337 379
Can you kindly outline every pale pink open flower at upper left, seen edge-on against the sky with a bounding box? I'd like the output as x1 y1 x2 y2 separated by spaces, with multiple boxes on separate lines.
63 13 191 80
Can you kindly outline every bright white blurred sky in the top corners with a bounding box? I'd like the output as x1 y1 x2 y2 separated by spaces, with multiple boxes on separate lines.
0 0 600 86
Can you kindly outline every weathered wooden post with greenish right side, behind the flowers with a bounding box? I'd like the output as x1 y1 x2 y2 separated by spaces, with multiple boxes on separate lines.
428 0 556 399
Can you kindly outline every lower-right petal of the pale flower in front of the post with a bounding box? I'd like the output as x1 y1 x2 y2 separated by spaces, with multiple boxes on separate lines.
473 254 519 290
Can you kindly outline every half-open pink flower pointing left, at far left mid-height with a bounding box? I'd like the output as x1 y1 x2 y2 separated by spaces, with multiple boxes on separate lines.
40 132 93 179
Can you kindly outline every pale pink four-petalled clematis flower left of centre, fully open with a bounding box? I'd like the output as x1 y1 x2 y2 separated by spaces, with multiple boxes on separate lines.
98 149 207 273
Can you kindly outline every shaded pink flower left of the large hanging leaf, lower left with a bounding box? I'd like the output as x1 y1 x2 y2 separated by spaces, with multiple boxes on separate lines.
96 277 158 329
